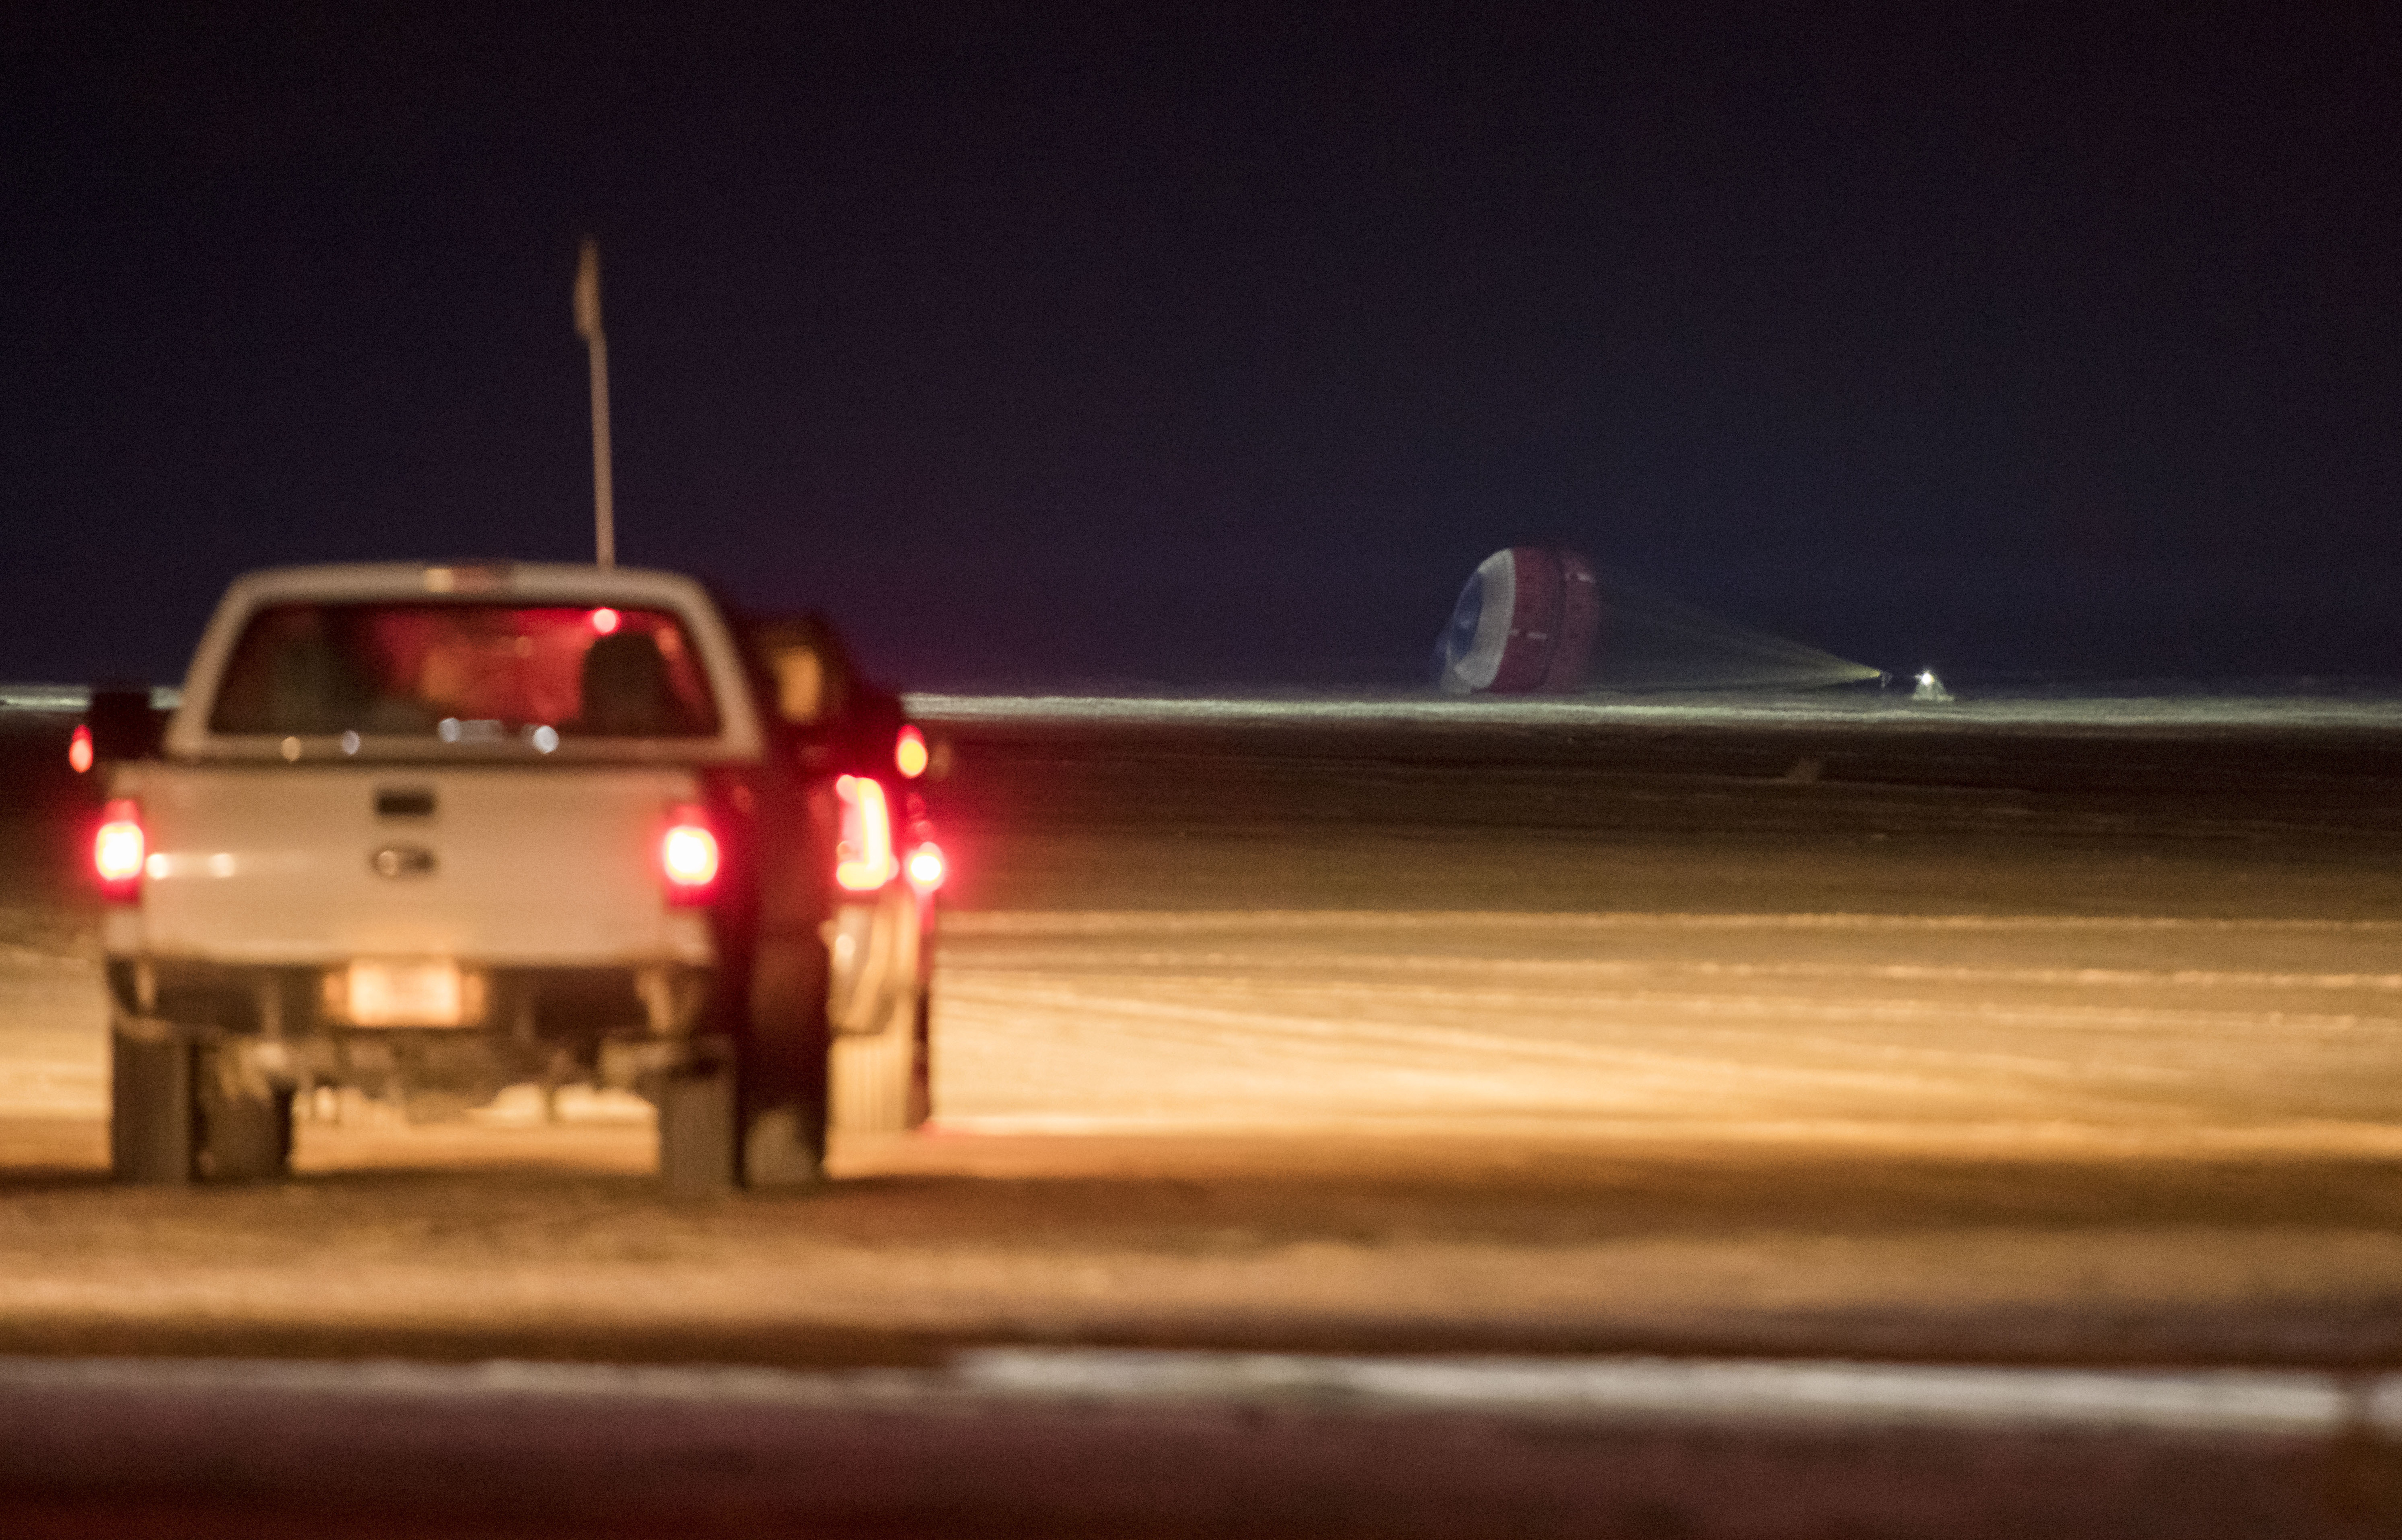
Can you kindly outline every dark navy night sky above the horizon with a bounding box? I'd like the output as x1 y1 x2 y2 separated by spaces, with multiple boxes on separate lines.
0 2 2402 687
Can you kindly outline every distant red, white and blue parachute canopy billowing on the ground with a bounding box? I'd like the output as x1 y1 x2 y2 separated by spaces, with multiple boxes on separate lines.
1434 545 1602 694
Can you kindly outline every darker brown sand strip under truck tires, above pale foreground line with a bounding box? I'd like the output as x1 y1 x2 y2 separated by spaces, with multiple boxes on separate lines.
0 1124 2402 1365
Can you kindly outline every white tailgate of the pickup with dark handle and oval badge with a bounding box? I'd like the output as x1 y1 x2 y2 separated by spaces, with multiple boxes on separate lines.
130 764 709 966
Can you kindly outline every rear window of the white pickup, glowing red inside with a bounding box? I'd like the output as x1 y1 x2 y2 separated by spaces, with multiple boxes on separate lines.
209 603 718 747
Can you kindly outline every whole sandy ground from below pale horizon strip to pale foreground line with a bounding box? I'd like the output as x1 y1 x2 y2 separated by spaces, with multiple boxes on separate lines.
0 706 2402 1365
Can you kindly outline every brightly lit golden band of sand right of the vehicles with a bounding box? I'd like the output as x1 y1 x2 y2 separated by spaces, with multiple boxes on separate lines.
934 913 2402 1151
